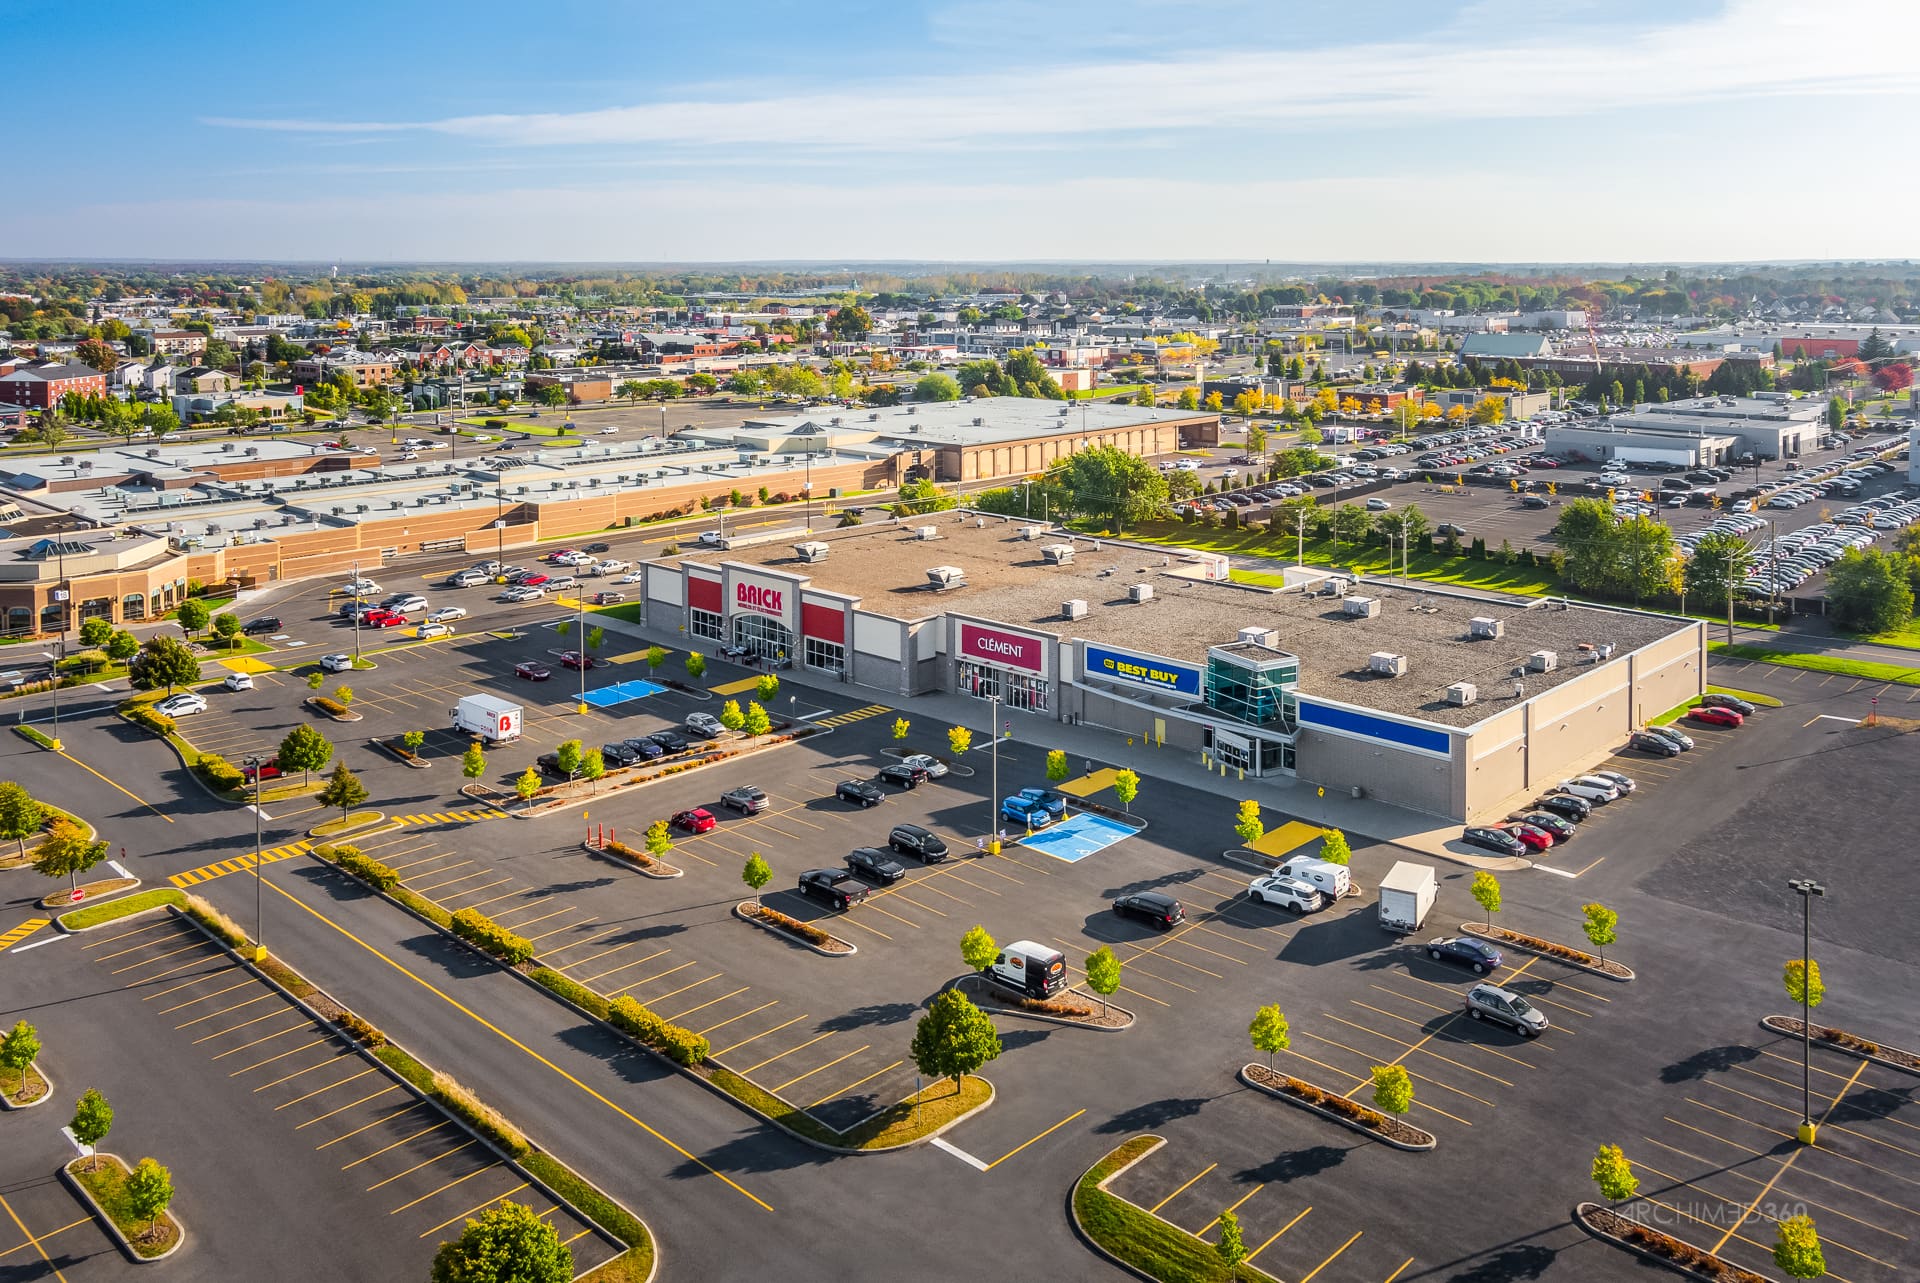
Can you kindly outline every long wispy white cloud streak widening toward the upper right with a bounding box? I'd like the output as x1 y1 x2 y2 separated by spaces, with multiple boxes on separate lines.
207 0 1920 152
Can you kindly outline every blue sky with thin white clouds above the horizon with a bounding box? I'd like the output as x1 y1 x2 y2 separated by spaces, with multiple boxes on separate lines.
0 0 1920 261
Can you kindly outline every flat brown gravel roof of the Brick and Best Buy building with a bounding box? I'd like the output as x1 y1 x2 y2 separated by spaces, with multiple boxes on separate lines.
684 513 1692 726
